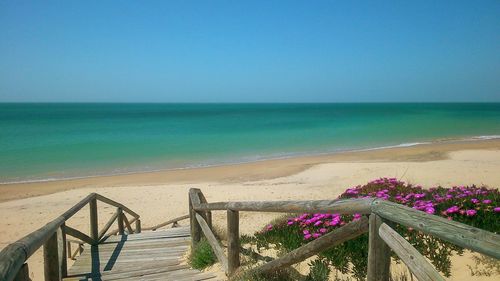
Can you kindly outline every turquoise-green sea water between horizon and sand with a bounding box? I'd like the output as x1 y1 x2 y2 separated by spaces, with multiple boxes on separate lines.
0 103 500 182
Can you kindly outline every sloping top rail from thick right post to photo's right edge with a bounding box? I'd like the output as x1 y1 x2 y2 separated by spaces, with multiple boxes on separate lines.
372 199 500 259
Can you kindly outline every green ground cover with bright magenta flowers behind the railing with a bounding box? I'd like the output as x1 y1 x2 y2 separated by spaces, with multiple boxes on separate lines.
248 178 500 280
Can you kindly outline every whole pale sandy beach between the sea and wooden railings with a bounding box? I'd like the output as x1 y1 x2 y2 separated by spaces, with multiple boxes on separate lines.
0 140 500 280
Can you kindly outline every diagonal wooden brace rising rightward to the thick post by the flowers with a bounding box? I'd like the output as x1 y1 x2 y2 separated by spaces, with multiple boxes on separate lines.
252 217 368 273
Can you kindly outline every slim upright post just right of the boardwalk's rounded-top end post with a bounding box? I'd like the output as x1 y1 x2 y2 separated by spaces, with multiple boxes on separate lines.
227 210 240 276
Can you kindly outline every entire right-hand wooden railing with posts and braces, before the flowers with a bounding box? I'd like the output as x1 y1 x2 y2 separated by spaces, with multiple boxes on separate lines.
189 189 500 281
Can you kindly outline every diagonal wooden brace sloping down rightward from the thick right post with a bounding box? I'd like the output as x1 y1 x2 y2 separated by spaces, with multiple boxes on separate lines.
379 223 444 281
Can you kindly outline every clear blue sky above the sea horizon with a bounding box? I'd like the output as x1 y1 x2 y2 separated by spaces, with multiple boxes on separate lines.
0 0 500 102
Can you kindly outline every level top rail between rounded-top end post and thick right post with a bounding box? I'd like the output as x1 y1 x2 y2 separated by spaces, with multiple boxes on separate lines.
194 199 374 214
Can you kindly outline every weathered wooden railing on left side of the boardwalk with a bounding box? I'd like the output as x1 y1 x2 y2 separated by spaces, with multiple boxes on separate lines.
0 193 141 281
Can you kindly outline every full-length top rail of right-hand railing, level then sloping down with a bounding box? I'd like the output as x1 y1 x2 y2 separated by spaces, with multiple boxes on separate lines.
193 195 500 259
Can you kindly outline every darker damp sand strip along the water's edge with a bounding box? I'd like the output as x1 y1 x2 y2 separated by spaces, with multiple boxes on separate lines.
0 138 500 202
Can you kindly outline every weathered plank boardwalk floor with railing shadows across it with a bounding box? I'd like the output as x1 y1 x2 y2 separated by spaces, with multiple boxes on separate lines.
64 227 216 281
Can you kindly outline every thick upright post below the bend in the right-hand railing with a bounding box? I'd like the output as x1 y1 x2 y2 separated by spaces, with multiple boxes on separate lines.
367 214 391 281
